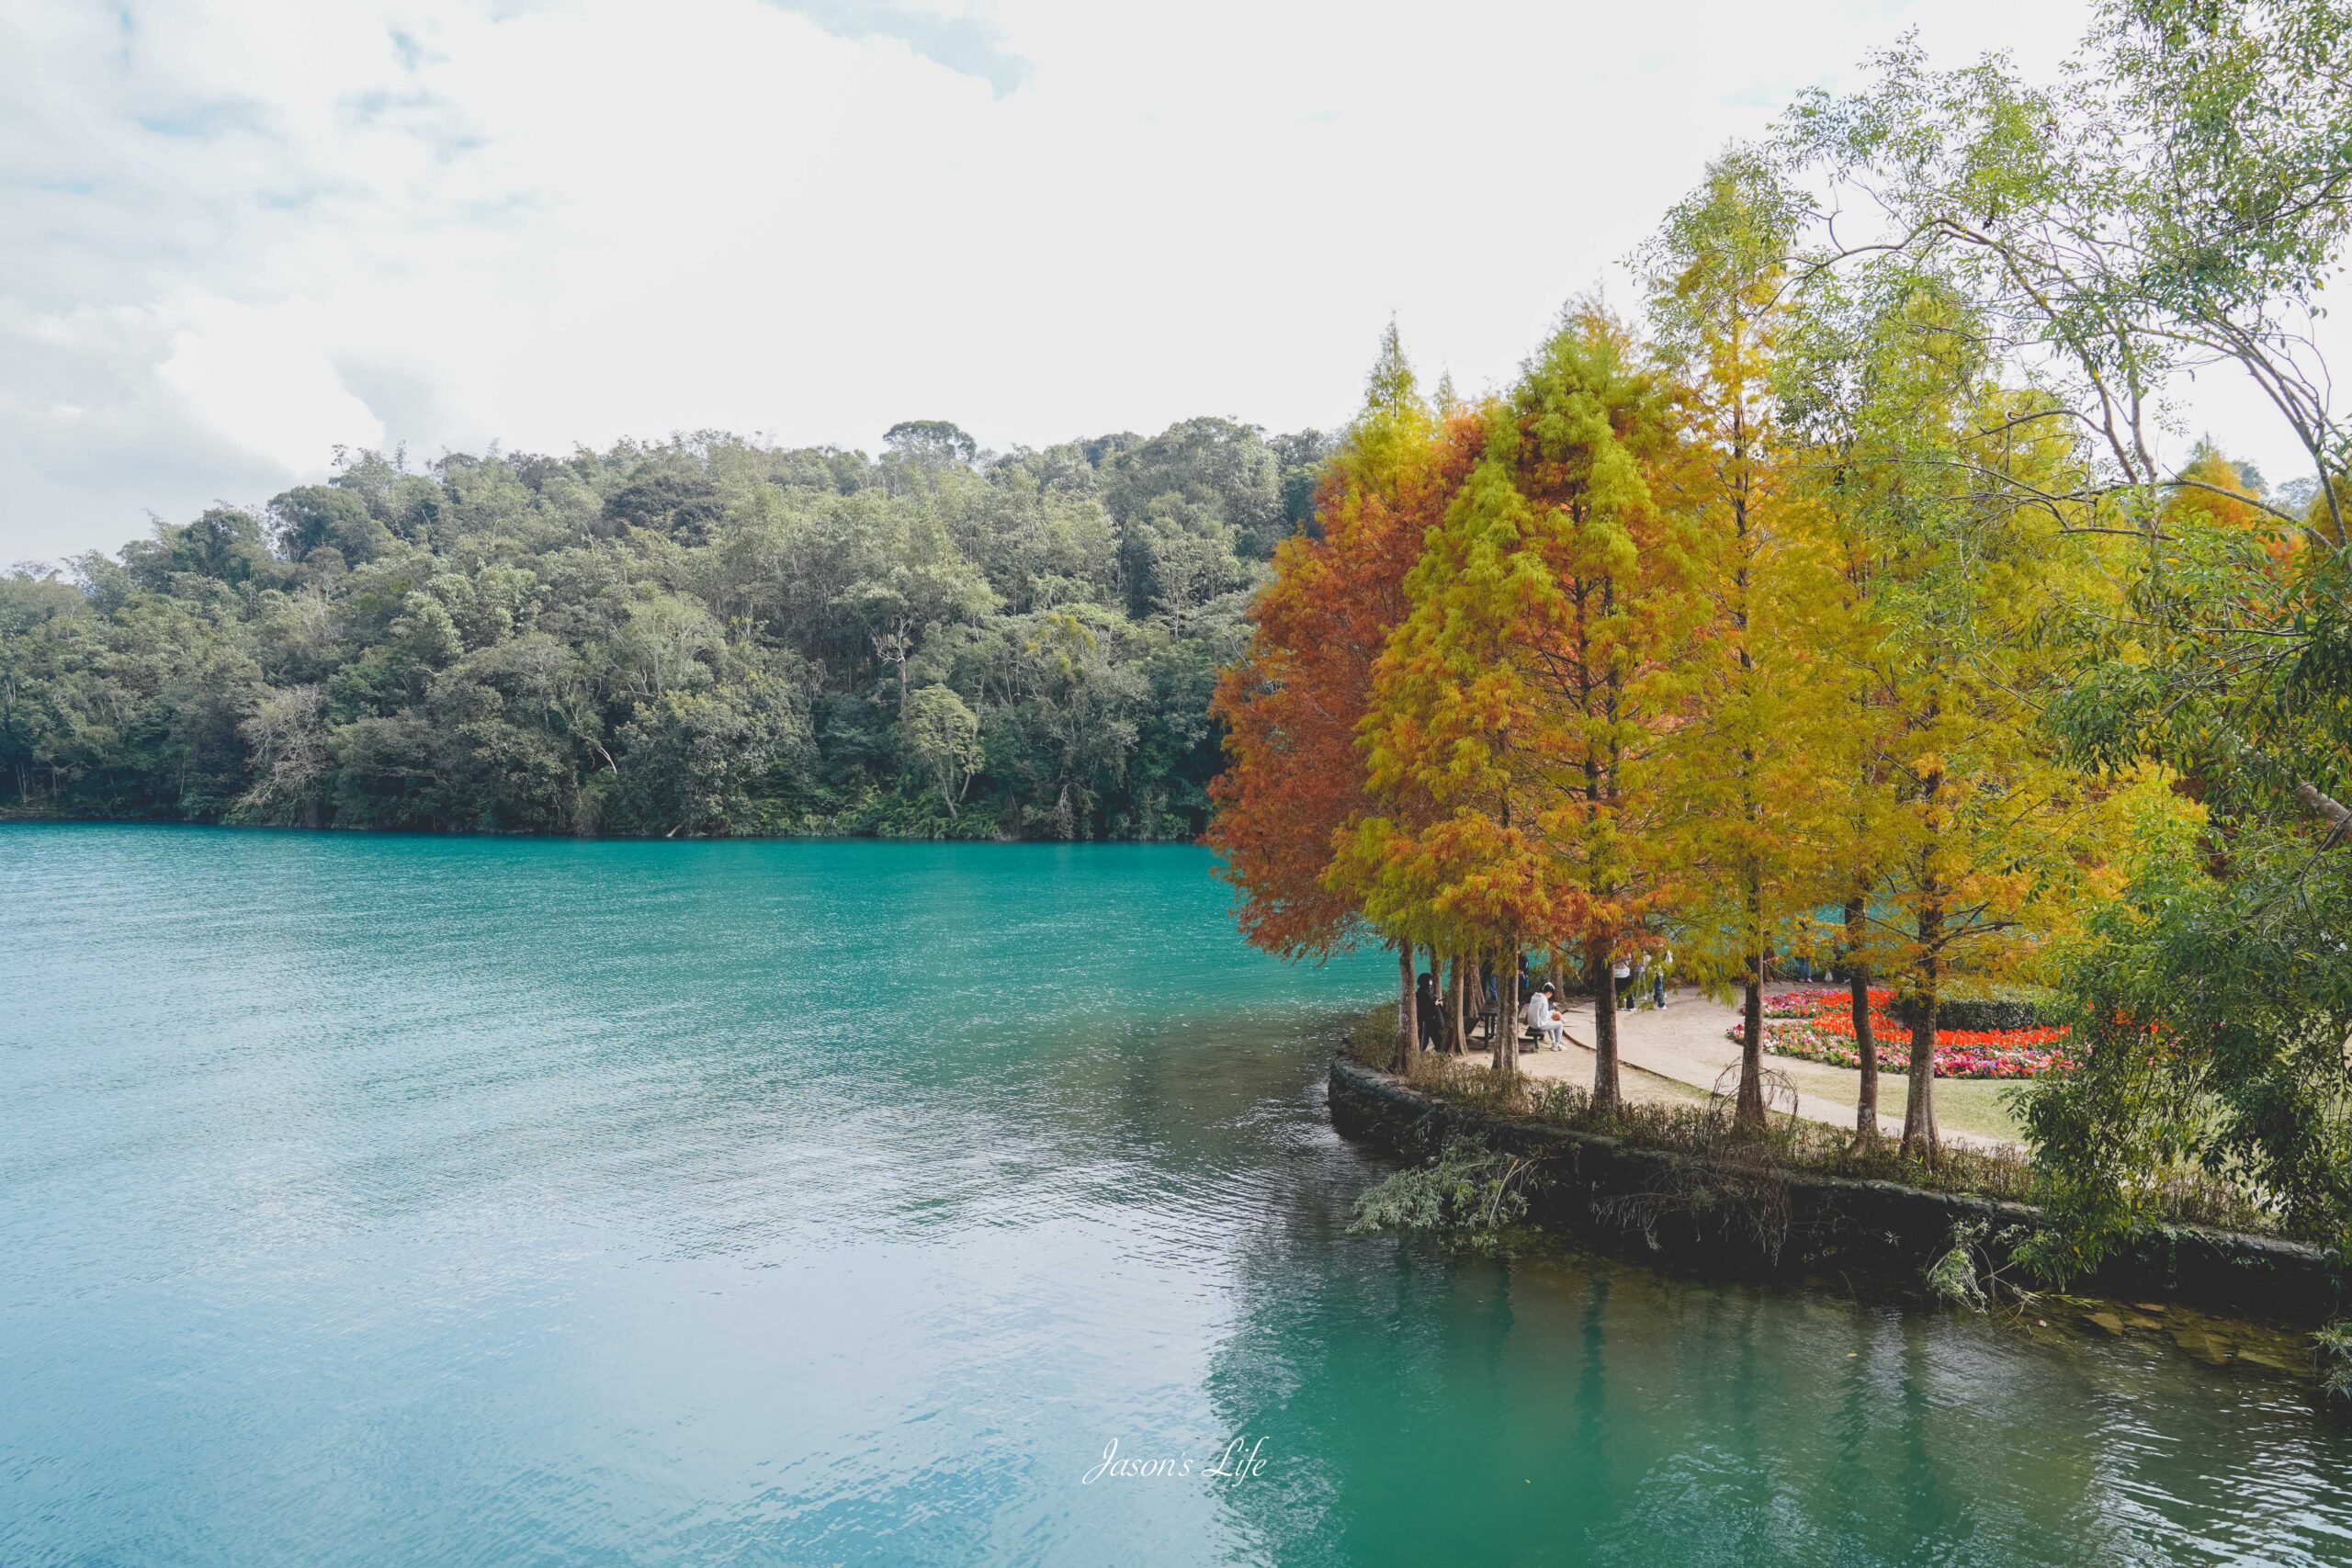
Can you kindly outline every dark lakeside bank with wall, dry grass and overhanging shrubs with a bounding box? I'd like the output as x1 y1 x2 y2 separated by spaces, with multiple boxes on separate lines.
1329 1042 2343 1354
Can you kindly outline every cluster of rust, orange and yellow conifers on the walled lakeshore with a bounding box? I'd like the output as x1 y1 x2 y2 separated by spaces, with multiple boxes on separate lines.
1209 251 2144 1149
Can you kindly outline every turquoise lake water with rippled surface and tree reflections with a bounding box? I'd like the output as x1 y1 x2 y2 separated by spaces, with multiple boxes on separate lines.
0 825 2352 1568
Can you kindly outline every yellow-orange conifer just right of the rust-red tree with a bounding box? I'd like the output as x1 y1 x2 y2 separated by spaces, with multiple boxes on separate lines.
1334 308 1689 1102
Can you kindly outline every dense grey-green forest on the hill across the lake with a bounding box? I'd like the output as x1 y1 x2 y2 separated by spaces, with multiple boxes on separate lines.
0 419 1327 840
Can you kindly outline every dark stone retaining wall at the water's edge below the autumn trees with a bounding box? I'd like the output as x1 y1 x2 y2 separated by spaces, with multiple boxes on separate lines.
1331 1058 2345 1324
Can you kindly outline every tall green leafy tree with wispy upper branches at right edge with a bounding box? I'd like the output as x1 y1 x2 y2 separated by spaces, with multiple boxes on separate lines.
1790 0 2352 1189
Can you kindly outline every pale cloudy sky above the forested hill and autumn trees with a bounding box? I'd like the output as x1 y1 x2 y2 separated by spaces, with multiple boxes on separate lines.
0 0 2314 562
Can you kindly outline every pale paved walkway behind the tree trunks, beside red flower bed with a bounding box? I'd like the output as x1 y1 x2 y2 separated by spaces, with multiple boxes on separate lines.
1470 989 2016 1147
